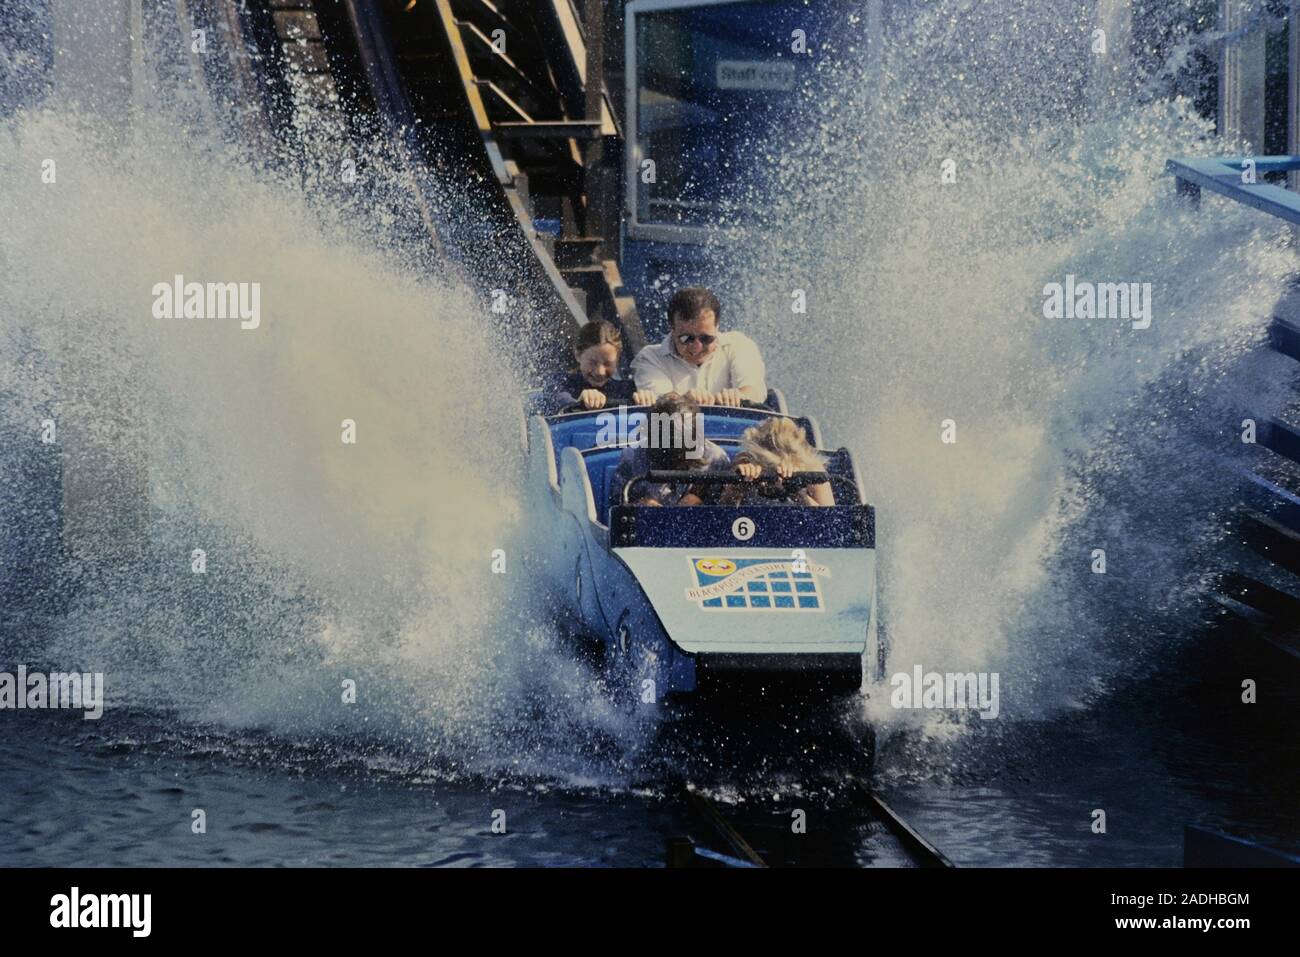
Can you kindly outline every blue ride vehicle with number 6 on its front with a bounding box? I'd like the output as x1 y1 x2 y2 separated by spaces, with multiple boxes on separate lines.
527 390 884 700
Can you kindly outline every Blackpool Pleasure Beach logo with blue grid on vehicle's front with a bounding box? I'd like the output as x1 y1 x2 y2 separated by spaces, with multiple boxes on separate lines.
686 555 831 612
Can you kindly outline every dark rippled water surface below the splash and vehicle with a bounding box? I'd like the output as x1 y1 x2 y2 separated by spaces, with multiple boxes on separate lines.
0 621 1300 867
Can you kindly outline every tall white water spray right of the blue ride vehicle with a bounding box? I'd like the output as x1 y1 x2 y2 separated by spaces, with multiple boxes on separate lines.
745 1 1294 726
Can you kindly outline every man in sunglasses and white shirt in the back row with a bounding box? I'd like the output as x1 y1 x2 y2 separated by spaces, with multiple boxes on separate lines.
632 286 767 407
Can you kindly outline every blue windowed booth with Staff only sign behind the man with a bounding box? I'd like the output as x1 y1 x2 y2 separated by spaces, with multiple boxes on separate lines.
620 0 880 341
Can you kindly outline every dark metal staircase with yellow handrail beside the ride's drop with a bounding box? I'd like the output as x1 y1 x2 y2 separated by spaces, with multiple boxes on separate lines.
378 0 645 354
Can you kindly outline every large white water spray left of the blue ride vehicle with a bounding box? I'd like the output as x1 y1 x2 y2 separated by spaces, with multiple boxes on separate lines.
0 91 644 776
